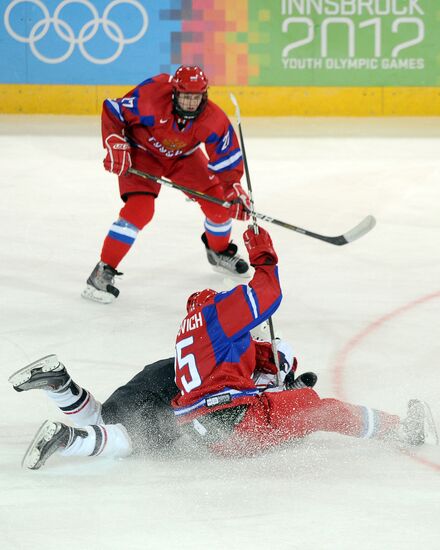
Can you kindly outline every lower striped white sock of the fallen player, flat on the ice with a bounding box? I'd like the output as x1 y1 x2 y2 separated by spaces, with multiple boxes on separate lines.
60 424 132 458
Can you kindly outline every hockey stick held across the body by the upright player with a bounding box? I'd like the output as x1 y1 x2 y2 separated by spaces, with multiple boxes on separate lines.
128 168 376 246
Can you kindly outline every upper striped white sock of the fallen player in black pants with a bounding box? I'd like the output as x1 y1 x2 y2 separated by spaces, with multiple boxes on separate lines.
46 380 103 426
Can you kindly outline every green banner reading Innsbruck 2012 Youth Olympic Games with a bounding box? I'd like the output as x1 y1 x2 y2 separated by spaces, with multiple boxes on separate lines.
249 0 440 86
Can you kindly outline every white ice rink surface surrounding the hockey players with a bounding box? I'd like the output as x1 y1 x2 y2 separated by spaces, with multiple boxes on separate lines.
0 116 440 550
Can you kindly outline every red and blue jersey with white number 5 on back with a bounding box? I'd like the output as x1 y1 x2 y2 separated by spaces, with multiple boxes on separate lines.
172 265 282 422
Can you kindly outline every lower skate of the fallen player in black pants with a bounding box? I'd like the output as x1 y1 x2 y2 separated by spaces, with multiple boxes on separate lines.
21 420 88 470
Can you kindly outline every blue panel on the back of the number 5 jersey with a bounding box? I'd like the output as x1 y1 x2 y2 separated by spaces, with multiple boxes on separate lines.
202 300 251 364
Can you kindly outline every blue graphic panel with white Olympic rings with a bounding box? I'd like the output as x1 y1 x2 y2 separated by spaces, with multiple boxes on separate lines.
0 0 185 84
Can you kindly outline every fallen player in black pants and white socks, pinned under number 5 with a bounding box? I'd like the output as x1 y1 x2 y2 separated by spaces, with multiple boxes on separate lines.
9 340 316 470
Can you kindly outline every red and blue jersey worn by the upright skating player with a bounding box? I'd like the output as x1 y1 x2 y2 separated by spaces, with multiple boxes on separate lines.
102 74 243 184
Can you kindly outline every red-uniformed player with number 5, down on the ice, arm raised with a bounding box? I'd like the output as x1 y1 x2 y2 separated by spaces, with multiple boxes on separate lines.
172 228 435 456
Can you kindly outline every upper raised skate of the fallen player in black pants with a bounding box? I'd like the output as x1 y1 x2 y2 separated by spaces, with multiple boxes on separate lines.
8 355 70 391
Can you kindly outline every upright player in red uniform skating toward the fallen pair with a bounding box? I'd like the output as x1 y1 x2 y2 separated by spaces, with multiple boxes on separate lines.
82 66 249 303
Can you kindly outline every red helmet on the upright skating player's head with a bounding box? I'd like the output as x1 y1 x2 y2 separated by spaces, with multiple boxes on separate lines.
172 65 208 120
